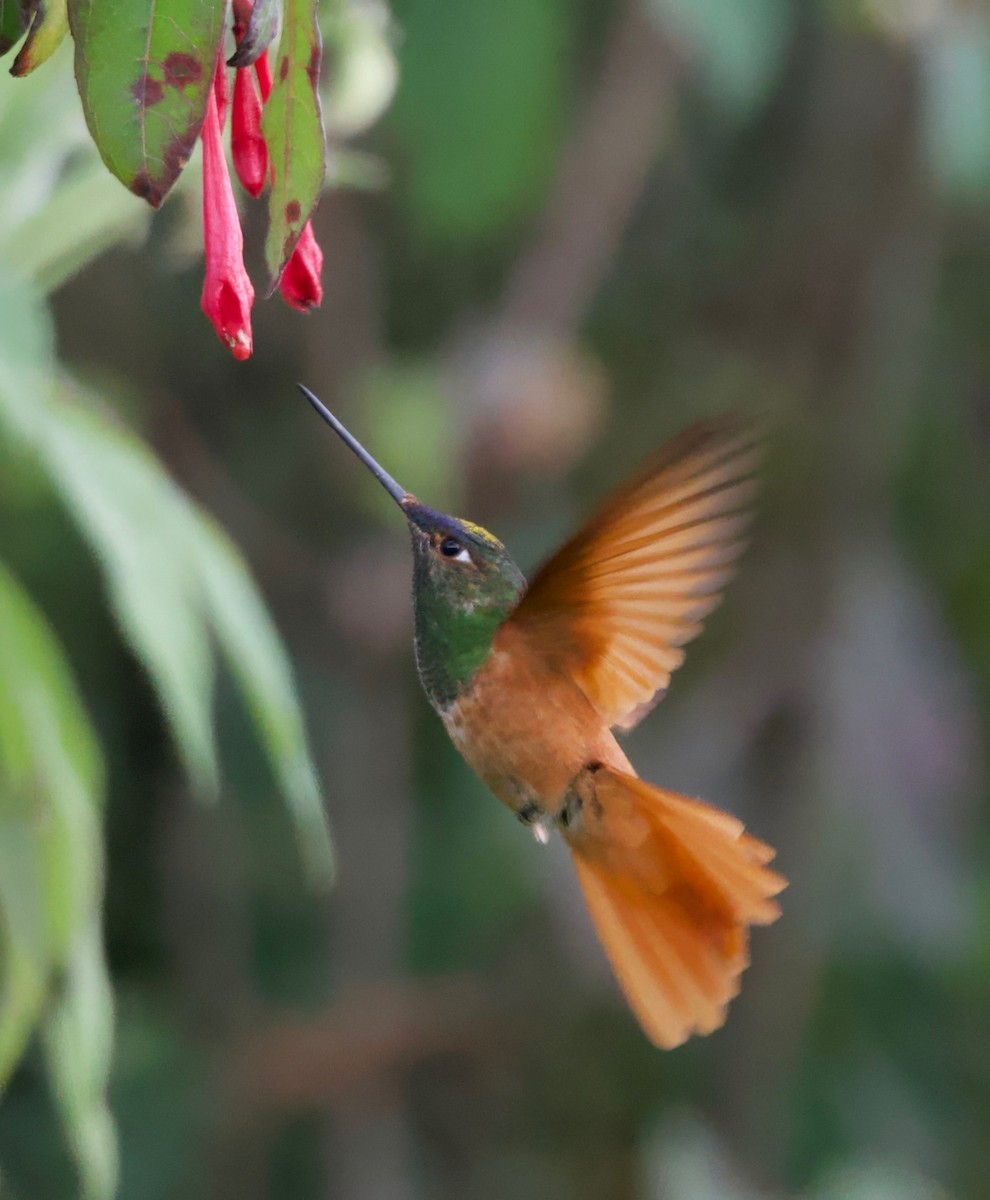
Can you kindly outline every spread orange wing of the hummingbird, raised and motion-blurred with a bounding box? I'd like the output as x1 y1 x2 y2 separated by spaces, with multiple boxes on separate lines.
506 419 760 728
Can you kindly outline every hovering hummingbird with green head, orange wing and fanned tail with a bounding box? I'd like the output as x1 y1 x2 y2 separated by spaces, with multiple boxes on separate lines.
299 384 787 1049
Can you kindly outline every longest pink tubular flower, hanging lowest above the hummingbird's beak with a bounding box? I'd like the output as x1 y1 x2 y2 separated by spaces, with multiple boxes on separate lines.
200 62 254 360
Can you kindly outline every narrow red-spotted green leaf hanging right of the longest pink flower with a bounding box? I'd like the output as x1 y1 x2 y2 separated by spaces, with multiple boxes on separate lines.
262 0 325 292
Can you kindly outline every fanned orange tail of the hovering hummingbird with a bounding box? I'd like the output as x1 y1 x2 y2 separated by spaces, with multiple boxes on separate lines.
569 767 786 1049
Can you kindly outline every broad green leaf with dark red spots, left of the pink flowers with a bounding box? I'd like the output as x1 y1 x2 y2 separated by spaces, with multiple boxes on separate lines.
68 0 227 208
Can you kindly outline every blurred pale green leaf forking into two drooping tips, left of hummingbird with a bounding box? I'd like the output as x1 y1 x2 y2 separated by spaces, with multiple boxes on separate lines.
0 274 331 881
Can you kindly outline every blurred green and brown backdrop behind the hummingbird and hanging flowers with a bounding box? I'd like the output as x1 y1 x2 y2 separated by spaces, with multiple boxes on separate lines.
0 0 990 1200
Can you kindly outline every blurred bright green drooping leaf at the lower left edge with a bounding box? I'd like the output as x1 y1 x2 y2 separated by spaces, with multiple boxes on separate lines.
0 566 115 1200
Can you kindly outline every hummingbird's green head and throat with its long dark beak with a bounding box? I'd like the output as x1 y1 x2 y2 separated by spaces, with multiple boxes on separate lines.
299 384 526 712
